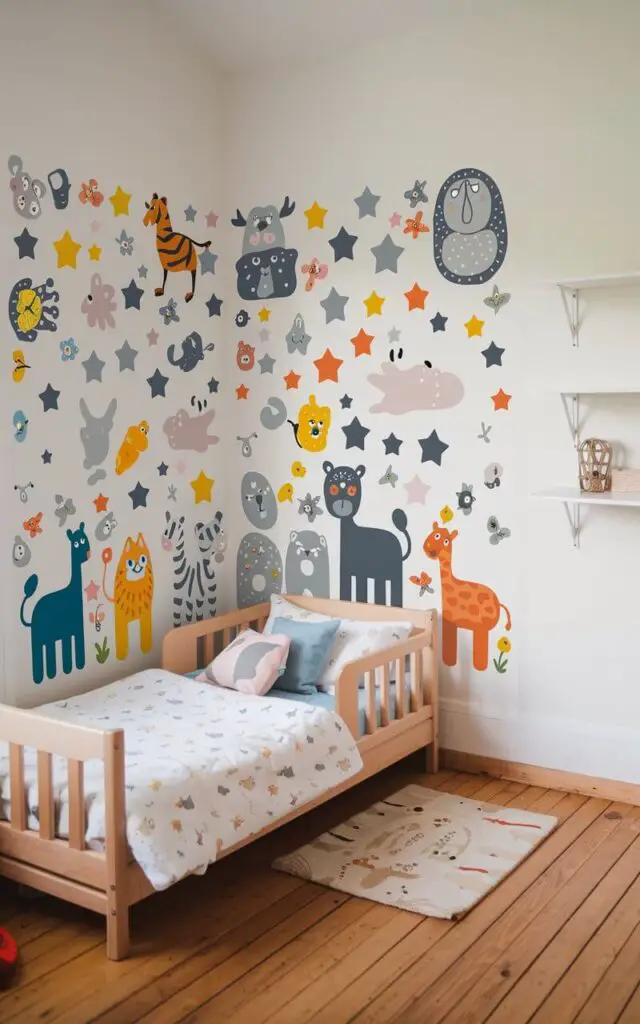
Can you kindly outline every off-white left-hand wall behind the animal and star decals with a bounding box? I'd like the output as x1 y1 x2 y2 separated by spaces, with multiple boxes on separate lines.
0 0 225 705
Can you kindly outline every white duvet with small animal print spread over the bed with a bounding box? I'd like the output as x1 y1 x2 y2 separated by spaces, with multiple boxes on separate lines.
0 669 362 889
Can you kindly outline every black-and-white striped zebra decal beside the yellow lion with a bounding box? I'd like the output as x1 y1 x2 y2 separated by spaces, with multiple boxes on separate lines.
162 512 226 629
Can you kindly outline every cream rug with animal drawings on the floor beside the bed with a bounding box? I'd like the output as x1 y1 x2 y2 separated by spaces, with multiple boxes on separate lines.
272 785 557 921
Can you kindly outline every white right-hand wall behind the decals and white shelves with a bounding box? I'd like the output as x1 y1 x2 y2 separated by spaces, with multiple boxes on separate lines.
224 0 640 782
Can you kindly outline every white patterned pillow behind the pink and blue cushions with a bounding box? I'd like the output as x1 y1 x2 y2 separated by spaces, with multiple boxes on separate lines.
264 594 413 693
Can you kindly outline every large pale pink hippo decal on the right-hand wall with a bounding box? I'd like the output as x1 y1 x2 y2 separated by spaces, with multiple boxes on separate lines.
367 359 465 416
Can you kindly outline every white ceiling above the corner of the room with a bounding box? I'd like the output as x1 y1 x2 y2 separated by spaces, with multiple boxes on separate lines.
157 0 421 75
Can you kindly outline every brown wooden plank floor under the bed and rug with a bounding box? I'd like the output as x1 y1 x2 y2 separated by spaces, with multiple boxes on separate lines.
0 766 640 1024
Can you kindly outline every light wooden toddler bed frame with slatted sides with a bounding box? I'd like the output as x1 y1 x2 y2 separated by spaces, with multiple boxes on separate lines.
0 595 438 959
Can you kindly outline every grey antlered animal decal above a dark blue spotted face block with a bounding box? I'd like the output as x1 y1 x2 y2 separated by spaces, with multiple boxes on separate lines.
231 196 298 300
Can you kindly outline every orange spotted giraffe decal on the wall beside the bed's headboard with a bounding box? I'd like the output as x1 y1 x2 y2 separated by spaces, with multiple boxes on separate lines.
423 522 511 672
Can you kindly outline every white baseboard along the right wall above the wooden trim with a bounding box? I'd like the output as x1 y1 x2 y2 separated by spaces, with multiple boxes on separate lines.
439 700 640 783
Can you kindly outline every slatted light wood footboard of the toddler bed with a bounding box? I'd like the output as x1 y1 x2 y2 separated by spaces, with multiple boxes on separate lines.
0 706 129 959
